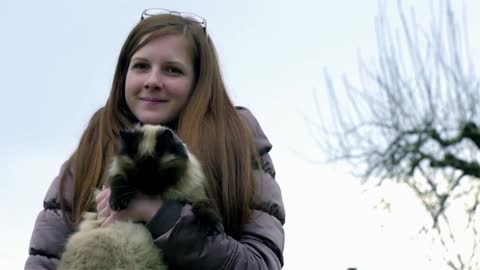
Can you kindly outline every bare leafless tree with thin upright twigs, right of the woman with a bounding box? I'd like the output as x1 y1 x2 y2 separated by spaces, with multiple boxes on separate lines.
317 0 480 270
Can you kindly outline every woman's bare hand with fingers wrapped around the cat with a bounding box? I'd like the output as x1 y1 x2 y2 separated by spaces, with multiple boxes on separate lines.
95 187 163 227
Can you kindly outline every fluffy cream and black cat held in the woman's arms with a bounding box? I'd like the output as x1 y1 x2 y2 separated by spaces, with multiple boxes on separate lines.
58 125 221 270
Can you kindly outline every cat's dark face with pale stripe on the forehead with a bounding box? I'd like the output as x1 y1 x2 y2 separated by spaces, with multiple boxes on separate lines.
118 125 188 195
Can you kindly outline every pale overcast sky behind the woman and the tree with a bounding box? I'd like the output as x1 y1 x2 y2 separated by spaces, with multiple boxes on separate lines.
0 0 480 270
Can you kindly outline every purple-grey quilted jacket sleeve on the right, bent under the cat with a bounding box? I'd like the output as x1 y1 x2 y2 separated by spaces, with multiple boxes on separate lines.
147 108 285 270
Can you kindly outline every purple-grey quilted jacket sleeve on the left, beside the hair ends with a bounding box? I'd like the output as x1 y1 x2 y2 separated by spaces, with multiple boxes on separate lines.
25 165 72 270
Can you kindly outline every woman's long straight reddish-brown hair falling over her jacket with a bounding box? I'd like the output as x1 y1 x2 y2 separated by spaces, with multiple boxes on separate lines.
60 15 256 237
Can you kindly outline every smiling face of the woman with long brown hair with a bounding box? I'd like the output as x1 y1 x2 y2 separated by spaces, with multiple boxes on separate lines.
125 35 195 125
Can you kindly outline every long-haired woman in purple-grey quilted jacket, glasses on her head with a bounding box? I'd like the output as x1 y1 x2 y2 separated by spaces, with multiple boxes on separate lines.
25 9 285 270
